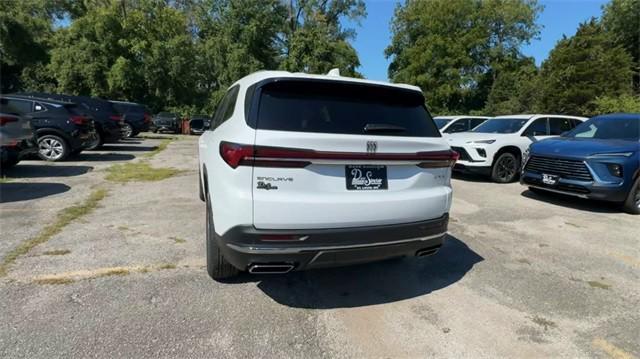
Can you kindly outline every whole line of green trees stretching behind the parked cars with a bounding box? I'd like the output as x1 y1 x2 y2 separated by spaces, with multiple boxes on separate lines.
0 0 640 115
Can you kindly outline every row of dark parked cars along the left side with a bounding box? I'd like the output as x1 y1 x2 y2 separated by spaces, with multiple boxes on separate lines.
0 92 151 169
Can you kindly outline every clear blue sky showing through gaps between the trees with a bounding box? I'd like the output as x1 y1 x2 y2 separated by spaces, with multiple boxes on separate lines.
347 0 607 81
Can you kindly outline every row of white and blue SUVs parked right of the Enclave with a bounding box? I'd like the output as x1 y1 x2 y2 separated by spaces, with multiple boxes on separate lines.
434 114 640 214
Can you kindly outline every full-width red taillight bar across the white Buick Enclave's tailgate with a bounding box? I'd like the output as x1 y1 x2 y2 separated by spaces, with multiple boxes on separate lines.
220 141 459 168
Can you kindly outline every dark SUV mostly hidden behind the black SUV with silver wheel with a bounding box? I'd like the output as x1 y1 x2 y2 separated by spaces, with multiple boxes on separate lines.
20 92 124 150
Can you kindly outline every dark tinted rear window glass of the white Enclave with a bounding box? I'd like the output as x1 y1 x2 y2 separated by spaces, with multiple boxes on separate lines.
257 81 440 137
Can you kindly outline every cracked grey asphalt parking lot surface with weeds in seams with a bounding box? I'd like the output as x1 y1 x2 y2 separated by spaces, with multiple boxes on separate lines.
0 136 640 358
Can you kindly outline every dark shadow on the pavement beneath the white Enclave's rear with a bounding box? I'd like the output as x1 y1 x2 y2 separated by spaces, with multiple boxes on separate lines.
215 235 484 309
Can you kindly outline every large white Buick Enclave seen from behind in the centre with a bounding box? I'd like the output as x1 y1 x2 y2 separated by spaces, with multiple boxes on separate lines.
199 71 457 279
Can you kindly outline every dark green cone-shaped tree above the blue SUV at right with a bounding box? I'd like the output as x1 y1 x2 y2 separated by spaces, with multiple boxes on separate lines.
539 19 633 115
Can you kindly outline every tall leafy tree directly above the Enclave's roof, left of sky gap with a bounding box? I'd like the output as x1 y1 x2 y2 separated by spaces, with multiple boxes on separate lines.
280 0 366 77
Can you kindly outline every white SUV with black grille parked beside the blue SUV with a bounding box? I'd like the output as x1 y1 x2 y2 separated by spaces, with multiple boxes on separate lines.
447 115 586 183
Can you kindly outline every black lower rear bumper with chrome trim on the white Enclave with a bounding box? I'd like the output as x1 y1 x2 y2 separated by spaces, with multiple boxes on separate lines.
217 214 449 270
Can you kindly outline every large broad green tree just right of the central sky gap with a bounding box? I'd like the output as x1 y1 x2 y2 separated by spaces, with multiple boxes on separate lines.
385 0 541 113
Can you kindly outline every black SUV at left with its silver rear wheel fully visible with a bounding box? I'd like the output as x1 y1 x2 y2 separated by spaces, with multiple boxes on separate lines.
0 95 96 161
